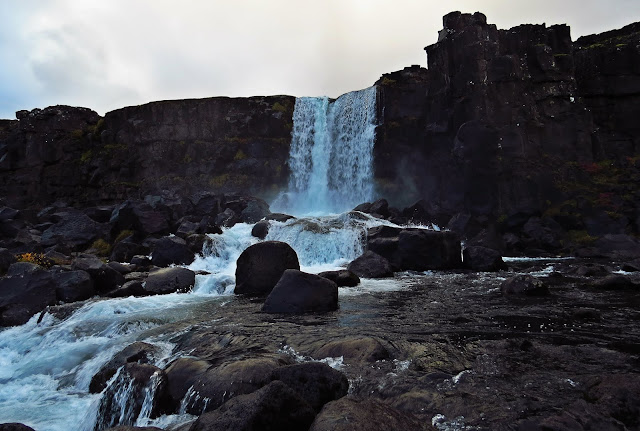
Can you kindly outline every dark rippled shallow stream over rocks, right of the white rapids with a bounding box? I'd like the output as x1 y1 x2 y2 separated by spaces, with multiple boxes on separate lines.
164 259 640 430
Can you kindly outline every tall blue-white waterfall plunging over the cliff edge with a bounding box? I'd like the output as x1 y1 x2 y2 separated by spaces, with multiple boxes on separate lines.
272 87 376 214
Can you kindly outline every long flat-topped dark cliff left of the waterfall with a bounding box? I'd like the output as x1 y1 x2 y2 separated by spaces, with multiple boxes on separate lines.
0 96 295 207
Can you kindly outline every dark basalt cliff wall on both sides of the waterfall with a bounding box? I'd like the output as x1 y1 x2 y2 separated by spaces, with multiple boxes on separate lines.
0 12 640 254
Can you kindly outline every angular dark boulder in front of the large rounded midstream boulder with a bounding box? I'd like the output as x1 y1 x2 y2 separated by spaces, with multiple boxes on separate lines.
262 269 338 314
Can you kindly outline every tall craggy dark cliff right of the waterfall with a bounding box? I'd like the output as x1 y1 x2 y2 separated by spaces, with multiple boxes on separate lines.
375 12 640 245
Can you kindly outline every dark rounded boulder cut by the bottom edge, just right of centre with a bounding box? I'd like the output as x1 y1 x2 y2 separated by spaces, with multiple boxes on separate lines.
309 397 425 431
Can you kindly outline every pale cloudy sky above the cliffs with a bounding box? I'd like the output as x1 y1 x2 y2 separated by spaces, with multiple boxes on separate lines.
0 0 640 119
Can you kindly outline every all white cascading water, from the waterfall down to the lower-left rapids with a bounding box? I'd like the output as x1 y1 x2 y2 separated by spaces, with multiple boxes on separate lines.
0 87 420 431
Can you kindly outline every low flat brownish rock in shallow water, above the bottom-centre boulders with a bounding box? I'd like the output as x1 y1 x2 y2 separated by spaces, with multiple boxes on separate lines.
312 337 391 363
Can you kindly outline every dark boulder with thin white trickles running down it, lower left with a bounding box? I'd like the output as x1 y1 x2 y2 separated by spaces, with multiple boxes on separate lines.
95 362 168 430
